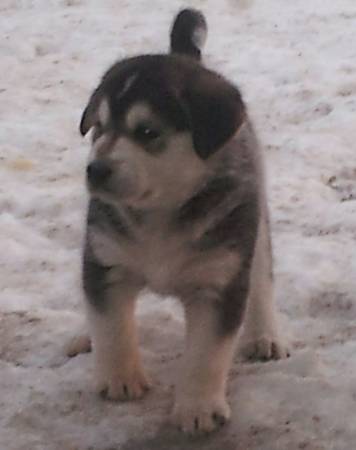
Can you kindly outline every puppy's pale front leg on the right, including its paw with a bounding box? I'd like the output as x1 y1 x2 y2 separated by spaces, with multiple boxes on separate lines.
172 294 243 433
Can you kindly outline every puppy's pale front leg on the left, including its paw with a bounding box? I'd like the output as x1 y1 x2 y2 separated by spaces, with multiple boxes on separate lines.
88 285 150 400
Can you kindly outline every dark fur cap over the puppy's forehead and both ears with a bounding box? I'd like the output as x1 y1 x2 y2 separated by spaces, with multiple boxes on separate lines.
80 55 245 159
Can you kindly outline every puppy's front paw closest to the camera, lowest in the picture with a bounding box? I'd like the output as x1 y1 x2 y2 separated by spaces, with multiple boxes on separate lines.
171 396 230 434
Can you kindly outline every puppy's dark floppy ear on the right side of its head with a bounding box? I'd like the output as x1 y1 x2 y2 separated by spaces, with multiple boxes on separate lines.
184 72 245 159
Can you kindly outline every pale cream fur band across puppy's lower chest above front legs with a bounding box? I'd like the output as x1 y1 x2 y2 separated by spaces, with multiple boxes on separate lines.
90 220 240 296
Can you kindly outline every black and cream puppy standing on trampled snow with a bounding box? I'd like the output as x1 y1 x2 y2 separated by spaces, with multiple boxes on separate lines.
72 9 286 433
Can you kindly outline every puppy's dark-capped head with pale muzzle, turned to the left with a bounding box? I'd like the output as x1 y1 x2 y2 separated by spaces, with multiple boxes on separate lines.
80 11 244 207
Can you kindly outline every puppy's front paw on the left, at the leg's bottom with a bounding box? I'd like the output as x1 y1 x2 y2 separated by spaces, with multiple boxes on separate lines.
96 368 151 401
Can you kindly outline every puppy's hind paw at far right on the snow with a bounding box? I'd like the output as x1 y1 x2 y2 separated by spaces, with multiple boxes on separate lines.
238 333 290 361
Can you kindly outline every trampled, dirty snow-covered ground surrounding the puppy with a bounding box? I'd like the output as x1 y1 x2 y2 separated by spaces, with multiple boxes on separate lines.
0 0 356 450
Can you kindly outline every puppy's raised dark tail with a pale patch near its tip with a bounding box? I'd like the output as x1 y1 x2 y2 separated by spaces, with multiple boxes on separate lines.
171 8 208 60
